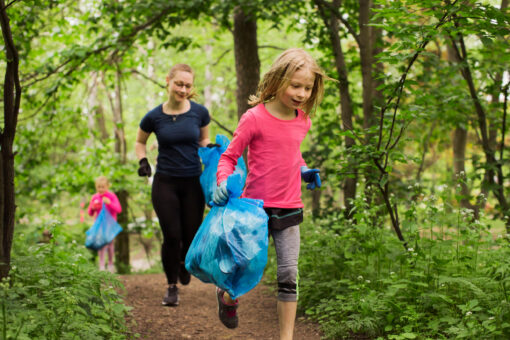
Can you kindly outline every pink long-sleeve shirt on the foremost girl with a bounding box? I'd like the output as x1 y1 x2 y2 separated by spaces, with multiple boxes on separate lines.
216 104 312 208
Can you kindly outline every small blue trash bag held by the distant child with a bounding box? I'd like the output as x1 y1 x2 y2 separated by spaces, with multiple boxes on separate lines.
85 203 122 250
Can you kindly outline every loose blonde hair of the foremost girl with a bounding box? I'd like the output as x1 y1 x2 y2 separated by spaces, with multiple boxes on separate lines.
248 48 331 115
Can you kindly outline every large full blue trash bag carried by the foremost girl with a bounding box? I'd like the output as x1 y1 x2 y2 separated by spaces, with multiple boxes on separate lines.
185 174 268 299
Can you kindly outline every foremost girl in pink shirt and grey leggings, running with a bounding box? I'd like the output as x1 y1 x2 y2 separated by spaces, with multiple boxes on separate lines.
213 48 329 339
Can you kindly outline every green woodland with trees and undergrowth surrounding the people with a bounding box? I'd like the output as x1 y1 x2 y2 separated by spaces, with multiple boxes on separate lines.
0 0 510 339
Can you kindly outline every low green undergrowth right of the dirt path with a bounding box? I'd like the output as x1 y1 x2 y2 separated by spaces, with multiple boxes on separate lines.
299 187 510 339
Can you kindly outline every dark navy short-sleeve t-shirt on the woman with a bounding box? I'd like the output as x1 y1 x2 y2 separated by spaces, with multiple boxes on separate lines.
140 101 211 177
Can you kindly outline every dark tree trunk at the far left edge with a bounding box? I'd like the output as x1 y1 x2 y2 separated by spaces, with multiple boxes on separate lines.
0 0 21 280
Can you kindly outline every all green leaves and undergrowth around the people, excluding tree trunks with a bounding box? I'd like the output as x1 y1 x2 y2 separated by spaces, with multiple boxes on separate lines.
0 0 510 339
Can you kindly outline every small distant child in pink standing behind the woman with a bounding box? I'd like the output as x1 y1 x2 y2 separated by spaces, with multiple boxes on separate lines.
87 176 122 273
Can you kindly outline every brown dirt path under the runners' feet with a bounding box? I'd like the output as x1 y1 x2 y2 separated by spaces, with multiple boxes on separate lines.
119 274 320 340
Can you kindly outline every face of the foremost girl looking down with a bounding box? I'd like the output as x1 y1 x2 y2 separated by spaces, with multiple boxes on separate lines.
277 68 315 110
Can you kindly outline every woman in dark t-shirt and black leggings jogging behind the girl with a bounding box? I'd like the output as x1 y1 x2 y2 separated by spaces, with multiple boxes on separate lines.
135 64 214 306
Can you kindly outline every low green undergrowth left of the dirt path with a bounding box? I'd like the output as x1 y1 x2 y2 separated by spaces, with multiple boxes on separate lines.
0 224 130 340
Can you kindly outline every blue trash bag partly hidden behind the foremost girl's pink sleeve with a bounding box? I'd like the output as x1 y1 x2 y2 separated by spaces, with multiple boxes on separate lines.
198 134 247 205
